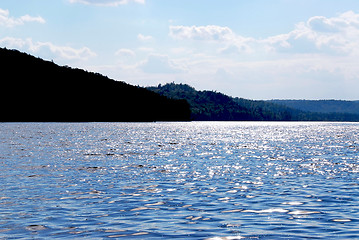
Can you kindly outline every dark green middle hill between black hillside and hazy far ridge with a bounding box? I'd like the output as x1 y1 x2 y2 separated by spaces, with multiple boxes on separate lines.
148 83 359 121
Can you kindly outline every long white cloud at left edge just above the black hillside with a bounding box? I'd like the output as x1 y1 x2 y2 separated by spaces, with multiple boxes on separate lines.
0 37 96 60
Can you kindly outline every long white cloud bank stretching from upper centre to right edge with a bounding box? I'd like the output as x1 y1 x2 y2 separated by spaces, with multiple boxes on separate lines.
169 11 359 55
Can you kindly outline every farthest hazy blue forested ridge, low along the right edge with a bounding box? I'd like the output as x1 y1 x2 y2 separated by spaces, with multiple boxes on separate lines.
269 100 359 114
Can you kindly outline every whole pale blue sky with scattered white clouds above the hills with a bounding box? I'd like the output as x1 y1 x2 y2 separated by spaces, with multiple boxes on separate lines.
0 0 359 100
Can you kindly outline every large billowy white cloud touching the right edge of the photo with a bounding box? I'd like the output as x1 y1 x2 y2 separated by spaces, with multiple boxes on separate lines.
262 11 359 55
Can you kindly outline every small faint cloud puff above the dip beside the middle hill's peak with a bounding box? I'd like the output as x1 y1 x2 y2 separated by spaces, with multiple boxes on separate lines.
139 54 184 74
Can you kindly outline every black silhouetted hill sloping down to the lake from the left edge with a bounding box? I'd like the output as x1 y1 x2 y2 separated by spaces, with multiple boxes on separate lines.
0 48 190 121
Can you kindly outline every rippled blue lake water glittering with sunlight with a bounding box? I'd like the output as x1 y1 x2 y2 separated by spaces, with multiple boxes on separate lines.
0 122 359 239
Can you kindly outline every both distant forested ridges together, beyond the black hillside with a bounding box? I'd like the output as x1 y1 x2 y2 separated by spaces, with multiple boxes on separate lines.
148 83 359 122
